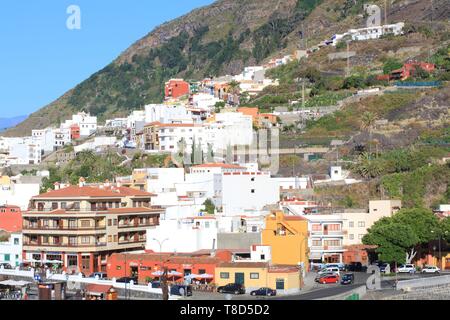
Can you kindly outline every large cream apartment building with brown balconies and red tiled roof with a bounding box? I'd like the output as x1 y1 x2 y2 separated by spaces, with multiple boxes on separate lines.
23 184 163 273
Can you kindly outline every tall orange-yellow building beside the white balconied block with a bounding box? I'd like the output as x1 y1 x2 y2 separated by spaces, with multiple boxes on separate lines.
262 211 309 268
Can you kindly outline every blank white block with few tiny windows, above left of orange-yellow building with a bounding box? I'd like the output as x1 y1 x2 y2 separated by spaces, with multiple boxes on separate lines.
214 172 280 216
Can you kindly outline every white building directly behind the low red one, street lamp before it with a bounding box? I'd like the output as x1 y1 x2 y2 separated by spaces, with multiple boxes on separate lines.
145 217 217 253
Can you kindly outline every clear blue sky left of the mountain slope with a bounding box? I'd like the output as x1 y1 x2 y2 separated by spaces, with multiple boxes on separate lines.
0 0 214 118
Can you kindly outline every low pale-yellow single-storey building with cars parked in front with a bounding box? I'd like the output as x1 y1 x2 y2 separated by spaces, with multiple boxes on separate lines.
215 262 301 294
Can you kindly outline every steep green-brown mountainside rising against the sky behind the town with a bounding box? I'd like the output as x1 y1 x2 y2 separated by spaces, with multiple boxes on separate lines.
5 0 449 136
